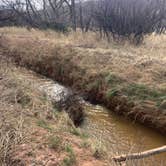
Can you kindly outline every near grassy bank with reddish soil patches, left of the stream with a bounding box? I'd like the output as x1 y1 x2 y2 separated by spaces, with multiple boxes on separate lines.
0 56 105 166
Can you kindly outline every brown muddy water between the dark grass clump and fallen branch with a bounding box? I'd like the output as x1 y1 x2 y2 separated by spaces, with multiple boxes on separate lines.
82 104 166 165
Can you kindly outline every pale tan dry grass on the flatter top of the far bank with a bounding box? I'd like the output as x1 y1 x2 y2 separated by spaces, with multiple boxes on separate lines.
0 27 166 88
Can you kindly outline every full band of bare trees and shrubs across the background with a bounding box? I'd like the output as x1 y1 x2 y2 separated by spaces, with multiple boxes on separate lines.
0 0 166 44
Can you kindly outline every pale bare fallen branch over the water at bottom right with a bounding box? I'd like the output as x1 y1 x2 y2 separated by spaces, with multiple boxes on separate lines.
112 145 166 162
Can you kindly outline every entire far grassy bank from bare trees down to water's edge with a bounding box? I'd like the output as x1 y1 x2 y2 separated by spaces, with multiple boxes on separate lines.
0 27 166 133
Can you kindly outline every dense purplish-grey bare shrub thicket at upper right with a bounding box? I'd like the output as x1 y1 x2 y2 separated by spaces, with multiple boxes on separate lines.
94 0 166 44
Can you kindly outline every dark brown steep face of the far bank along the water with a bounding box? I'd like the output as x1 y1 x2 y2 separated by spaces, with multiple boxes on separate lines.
1 40 166 135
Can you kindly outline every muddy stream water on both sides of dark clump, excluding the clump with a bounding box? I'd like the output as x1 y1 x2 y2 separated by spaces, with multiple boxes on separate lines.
18 72 166 165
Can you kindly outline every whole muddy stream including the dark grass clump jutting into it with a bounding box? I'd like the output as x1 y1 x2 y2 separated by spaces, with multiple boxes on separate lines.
10 67 166 165
